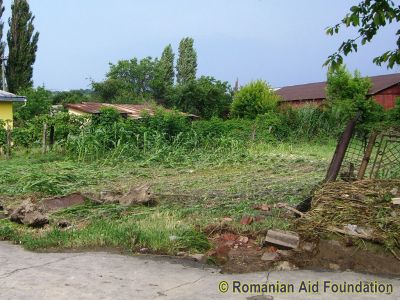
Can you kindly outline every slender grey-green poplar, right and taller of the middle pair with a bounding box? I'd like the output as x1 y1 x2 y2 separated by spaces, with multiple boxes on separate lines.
176 37 197 84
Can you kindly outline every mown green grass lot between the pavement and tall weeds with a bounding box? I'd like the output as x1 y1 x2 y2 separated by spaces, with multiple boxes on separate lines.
0 144 334 254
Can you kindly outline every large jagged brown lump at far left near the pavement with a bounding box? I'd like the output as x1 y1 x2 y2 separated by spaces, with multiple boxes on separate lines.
10 199 49 227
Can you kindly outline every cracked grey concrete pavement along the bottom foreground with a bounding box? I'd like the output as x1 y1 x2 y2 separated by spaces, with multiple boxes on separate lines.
0 242 400 300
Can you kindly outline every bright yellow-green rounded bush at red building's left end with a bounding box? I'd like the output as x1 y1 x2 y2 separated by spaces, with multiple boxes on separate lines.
231 80 279 119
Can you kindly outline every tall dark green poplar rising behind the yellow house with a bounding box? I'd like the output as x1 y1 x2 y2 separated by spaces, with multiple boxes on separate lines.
6 0 39 93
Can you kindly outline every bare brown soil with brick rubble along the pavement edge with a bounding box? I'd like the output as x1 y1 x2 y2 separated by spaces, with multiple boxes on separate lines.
207 233 400 276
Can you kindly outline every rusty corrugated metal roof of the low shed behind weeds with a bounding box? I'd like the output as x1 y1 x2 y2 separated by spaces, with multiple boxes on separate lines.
65 102 198 119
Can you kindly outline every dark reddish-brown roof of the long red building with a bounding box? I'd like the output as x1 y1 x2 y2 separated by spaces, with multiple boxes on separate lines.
276 73 400 101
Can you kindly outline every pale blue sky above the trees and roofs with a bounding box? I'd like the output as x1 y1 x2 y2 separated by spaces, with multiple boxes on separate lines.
4 0 399 90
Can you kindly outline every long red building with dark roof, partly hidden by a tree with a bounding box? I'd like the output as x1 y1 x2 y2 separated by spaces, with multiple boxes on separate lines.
276 73 400 109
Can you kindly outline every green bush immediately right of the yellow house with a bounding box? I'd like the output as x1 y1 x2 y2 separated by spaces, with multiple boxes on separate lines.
15 87 52 125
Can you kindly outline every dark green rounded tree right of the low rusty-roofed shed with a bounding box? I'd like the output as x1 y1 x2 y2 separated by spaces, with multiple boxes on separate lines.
167 76 232 119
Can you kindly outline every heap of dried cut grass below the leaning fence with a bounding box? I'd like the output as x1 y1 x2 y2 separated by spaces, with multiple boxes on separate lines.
297 180 400 259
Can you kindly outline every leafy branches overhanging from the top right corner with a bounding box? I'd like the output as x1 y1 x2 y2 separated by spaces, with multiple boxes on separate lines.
324 0 400 68
